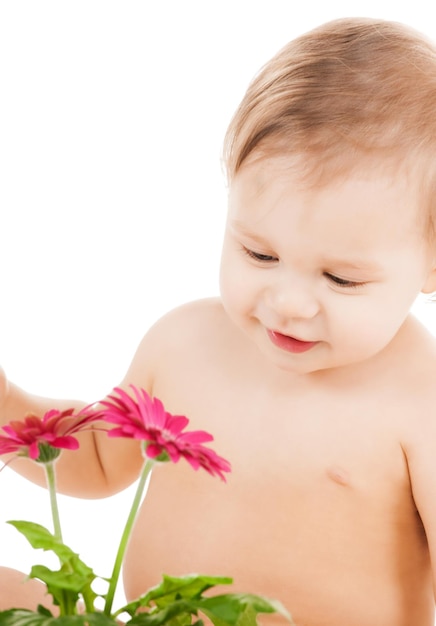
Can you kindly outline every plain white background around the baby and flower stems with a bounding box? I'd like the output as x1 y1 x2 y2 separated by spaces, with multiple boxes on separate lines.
0 0 436 616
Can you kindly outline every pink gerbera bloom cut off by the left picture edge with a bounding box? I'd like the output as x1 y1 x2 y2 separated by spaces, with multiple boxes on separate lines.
0 409 99 460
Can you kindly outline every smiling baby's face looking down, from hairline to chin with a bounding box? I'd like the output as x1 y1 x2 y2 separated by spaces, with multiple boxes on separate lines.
221 158 432 373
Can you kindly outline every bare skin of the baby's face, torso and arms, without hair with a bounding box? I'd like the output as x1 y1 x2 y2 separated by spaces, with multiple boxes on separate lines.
0 158 436 626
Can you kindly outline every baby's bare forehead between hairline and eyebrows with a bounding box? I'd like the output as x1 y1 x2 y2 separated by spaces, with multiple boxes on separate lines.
229 156 426 235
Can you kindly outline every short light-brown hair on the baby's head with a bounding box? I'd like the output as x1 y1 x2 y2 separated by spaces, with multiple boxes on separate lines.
224 18 436 210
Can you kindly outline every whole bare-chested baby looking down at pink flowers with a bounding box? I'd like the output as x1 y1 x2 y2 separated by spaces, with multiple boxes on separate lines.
0 19 436 626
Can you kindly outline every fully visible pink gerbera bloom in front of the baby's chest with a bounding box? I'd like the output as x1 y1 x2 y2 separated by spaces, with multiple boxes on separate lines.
101 385 230 481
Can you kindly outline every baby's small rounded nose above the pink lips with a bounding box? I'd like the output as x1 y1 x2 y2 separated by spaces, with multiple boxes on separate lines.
266 275 320 320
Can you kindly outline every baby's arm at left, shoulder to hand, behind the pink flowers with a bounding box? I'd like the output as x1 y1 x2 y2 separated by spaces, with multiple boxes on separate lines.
0 300 216 498
